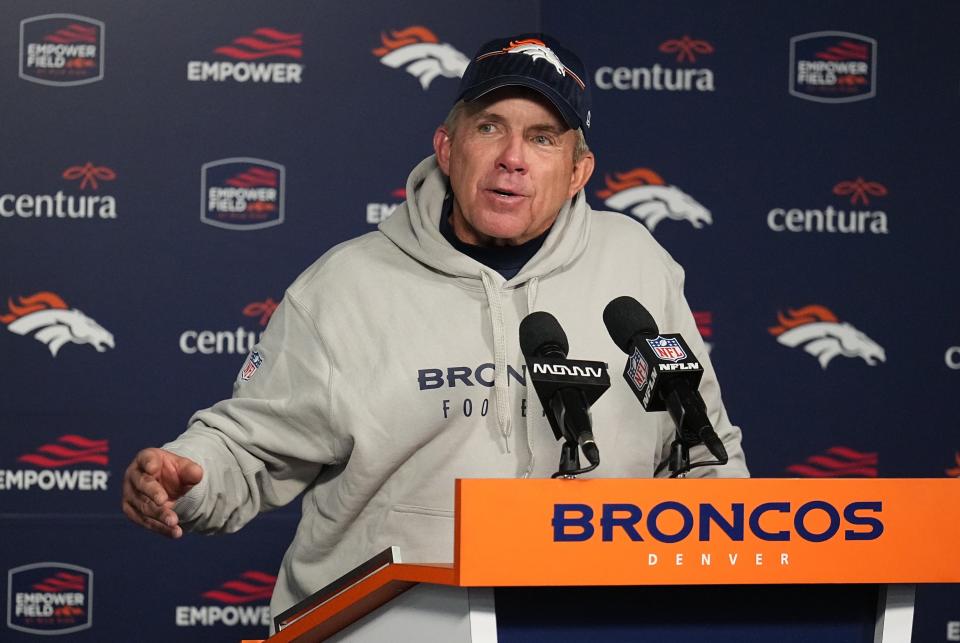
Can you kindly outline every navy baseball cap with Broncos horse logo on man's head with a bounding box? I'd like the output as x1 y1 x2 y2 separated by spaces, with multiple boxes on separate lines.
457 33 590 132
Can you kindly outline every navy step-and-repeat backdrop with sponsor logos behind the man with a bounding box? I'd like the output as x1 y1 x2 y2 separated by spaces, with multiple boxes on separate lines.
0 0 960 641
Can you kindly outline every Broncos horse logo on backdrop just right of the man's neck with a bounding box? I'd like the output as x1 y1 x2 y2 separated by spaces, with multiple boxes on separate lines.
597 167 713 232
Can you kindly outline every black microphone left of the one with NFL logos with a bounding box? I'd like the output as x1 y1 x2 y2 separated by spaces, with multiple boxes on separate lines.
520 311 610 473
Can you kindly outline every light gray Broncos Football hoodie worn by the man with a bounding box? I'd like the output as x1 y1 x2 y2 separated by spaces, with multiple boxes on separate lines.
165 157 748 614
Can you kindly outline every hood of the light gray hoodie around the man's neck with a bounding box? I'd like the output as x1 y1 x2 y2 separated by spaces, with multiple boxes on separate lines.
380 155 590 285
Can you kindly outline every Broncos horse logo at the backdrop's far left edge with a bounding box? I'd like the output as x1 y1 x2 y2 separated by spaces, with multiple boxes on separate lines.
0 291 114 357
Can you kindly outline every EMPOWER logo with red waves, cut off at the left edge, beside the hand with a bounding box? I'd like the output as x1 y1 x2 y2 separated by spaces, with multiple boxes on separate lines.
0 434 110 491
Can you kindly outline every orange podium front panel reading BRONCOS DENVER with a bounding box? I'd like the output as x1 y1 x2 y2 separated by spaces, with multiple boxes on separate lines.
454 479 960 586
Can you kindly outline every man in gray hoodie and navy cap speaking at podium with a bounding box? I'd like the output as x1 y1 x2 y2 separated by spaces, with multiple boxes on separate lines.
123 35 747 613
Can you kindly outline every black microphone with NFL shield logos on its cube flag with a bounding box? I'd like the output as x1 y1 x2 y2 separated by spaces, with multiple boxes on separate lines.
603 296 727 464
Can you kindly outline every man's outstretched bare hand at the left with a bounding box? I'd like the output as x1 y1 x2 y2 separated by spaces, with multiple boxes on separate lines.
123 449 203 538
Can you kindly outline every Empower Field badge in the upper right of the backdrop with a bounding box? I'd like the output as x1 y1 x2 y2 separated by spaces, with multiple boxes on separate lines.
790 31 877 103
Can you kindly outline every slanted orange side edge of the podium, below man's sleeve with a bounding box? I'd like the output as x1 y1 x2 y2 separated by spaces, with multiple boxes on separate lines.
267 563 457 643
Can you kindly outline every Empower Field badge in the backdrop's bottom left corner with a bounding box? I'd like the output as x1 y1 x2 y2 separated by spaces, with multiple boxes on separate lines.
7 562 93 635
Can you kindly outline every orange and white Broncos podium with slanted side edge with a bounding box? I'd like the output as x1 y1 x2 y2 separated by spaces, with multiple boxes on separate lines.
255 479 960 643
